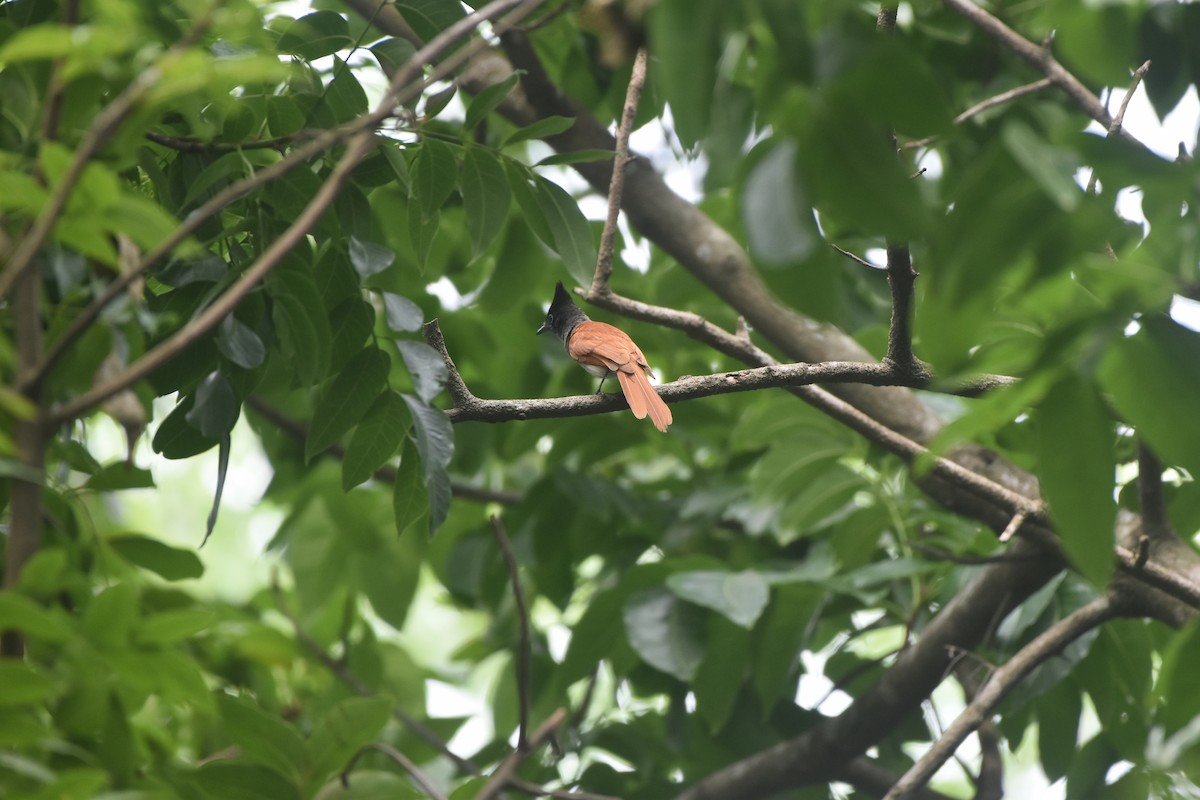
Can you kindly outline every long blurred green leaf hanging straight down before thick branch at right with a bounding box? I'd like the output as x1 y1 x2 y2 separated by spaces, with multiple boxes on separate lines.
1036 375 1116 587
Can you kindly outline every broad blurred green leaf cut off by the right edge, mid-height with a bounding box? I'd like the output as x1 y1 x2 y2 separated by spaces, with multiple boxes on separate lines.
1099 318 1200 475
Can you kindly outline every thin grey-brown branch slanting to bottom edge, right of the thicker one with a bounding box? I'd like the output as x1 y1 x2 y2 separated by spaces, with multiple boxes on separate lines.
883 596 1121 800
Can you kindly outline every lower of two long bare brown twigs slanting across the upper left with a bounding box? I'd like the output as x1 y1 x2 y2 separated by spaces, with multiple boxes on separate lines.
38 0 541 426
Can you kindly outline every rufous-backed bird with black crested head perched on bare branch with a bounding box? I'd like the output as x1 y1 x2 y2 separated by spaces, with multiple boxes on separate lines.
538 281 671 433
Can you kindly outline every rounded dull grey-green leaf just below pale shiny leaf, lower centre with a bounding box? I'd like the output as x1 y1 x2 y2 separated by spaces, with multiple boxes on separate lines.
622 589 704 681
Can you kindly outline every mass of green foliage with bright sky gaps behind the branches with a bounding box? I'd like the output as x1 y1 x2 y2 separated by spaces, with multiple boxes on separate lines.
0 0 1200 799
